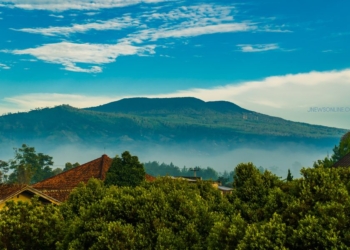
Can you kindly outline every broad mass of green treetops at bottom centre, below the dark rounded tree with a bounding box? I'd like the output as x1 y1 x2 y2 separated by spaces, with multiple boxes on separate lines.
59 177 230 249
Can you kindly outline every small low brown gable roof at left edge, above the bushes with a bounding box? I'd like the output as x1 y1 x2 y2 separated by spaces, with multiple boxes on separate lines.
0 184 60 204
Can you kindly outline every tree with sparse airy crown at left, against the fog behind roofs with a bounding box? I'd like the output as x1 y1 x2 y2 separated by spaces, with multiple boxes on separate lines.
9 144 53 183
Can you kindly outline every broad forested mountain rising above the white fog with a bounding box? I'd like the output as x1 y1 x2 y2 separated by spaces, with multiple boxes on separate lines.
0 98 346 147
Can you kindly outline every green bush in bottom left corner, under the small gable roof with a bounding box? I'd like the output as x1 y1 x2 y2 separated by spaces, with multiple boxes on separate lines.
0 198 64 250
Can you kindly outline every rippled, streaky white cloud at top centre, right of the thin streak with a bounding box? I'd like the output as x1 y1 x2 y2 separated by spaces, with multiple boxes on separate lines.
120 4 257 43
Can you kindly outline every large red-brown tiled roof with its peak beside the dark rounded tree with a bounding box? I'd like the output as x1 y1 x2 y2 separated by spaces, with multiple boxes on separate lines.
33 155 155 201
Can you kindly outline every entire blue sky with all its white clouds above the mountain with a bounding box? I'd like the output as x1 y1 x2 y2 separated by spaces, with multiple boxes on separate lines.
0 0 350 129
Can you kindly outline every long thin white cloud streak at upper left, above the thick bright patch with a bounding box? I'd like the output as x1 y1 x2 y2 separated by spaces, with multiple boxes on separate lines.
14 16 138 36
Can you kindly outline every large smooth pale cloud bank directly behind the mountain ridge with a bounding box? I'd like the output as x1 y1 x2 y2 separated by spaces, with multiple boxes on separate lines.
0 69 350 129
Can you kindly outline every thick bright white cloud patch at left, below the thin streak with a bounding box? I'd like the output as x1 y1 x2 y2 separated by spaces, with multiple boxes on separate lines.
7 42 155 73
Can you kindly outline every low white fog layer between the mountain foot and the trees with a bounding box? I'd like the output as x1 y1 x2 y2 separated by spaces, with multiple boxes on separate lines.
0 142 334 178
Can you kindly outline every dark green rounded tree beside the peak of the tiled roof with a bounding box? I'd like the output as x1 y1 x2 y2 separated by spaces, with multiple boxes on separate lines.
105 151 146 187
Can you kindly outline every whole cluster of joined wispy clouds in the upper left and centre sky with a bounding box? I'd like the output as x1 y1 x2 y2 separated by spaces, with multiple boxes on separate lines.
8 1 256 73
